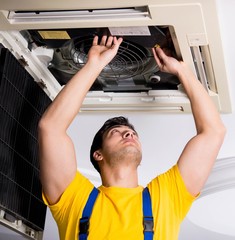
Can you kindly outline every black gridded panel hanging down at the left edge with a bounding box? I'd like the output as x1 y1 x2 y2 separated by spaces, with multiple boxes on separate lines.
0 48 51 230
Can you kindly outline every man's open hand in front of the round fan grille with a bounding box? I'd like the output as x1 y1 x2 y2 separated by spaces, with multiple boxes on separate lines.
88 36 123 68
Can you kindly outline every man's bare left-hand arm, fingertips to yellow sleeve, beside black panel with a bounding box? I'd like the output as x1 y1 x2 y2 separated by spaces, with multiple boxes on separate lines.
38 36 122 204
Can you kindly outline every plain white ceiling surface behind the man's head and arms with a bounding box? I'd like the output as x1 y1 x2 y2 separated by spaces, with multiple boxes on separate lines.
0 0 235 240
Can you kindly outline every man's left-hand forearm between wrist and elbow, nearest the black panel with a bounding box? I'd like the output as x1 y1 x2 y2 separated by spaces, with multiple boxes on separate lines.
41 62 102 131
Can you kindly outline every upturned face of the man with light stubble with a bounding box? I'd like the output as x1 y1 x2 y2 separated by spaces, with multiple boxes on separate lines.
98 126 142 169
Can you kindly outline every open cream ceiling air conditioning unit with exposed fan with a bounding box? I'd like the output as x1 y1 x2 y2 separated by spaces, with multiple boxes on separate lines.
0 0 232 112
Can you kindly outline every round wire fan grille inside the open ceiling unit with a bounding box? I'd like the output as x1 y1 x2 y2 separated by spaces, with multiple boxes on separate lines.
68 37 156 81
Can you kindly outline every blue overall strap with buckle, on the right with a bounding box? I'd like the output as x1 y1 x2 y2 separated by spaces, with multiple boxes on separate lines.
143 187 154 240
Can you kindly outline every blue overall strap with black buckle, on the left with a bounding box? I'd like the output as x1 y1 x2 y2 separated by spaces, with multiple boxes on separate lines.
79 187 99 240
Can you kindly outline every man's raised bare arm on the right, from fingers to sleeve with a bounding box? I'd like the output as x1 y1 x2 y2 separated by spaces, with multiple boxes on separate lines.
153 48 226 196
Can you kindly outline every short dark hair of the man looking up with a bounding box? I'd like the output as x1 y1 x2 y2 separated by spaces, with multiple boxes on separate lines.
90 116 135 173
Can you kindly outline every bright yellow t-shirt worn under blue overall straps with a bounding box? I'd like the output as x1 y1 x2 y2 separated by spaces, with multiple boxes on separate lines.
44 165 195 240
